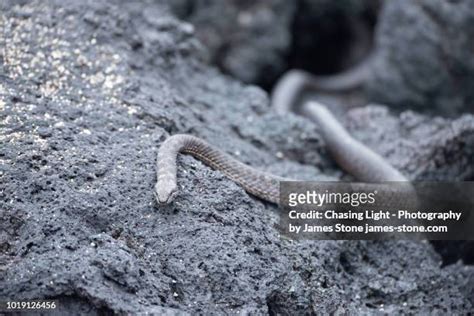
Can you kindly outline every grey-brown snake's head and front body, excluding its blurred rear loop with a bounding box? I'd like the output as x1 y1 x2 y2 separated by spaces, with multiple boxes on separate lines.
154 101 408 205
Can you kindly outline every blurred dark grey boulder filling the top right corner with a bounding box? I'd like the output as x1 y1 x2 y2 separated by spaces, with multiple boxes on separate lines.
368 0 474 115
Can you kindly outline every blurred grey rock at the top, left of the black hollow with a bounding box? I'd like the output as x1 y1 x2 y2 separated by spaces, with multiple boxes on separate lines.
170 0 296 88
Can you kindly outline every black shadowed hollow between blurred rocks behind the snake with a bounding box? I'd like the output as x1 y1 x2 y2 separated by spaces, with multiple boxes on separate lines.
257 1 379 91
